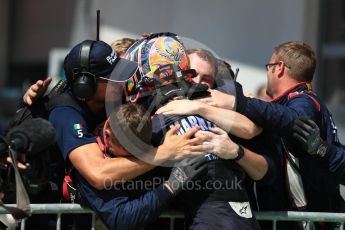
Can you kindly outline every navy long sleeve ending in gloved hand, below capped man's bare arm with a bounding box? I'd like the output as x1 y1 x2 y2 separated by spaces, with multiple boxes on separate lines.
76 173 173 229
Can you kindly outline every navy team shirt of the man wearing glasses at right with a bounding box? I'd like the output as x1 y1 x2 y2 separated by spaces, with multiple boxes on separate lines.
237 82 345 212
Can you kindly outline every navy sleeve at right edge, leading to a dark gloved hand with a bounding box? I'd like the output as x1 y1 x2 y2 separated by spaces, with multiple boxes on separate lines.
321 145 345 185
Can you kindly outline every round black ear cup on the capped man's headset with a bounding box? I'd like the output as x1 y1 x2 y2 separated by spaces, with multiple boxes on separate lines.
72 72 97 101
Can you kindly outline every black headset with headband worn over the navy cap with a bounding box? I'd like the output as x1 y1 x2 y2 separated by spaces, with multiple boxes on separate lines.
71 40 97 101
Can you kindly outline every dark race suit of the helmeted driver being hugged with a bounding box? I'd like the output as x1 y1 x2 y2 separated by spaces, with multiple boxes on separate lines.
152 112 252 226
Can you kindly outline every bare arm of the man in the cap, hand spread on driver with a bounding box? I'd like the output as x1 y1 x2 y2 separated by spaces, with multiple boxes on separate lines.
69 126 213 189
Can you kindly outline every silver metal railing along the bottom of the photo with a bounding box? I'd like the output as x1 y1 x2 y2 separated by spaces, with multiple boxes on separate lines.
0 204 345 230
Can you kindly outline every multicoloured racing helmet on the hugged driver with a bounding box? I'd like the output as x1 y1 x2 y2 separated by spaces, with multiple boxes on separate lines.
124 32 207 103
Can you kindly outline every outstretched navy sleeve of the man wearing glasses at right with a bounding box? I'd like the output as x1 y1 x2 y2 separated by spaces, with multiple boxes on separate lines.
241 95 318 136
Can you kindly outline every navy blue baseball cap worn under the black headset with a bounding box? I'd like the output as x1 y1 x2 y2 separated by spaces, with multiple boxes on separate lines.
64 41 138 81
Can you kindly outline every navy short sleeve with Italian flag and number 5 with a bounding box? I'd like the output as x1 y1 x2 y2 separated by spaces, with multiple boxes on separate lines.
49 106 97 160
